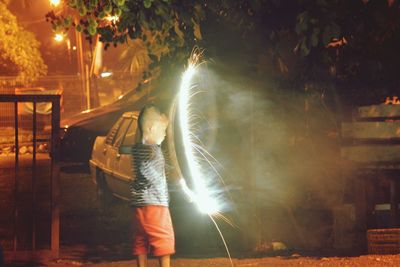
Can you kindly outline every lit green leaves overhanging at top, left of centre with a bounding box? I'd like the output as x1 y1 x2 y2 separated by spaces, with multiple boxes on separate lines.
47 0 203 69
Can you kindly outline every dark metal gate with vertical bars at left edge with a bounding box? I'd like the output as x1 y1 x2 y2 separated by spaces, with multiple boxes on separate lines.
0 94 60 261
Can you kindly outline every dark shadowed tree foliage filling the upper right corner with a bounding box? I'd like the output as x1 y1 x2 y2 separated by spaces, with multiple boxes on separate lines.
215 0 400 104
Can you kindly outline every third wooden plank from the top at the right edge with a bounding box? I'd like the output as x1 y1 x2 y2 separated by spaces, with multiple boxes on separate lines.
340 145 400 163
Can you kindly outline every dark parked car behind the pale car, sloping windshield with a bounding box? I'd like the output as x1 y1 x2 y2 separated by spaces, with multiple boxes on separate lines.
60 83 151 164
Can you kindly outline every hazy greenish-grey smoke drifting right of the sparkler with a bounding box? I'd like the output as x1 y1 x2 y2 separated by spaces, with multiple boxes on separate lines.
180 63 344 253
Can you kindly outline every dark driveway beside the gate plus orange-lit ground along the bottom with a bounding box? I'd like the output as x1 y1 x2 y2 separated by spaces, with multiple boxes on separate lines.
2 159 400 267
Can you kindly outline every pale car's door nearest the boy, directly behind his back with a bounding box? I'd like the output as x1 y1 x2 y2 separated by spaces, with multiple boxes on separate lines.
113 117 137 199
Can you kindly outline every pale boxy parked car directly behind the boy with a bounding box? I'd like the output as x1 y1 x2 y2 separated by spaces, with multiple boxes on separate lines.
89 112 138 204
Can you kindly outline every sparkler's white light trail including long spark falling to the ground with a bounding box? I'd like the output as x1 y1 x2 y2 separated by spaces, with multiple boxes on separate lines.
173 49 233 266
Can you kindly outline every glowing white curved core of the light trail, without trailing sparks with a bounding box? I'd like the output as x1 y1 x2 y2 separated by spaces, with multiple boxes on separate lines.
178 54 220 215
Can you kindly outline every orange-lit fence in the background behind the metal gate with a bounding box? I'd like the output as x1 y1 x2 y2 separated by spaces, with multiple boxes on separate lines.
0 72 140 129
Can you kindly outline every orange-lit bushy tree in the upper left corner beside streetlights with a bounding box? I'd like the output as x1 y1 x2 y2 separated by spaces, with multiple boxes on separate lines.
0 1 47 82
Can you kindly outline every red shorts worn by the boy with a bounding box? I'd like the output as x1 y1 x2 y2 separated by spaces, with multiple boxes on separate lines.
133 206 175 256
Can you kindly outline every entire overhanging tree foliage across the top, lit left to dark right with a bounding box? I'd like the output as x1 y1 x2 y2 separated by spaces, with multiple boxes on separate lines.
48 0 400 102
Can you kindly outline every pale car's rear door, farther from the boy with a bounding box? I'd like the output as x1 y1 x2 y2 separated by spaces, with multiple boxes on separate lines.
105 116 131 195
